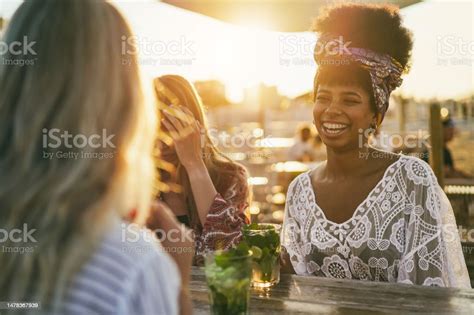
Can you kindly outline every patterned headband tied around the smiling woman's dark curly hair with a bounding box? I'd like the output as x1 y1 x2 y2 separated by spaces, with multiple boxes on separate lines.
314 33 403 123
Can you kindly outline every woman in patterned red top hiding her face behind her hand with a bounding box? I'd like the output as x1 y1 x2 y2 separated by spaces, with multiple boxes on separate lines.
155 75 249 255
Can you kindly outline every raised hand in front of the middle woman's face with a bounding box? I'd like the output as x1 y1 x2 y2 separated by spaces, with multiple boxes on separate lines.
162 105 203 170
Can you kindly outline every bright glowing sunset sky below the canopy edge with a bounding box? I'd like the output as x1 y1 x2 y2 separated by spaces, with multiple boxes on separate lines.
0 0 474 101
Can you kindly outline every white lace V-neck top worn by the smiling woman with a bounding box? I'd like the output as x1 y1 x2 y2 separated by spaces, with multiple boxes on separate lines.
282 156 471 288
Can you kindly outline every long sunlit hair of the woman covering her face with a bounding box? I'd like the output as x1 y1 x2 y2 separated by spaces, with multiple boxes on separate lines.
154 75 250 229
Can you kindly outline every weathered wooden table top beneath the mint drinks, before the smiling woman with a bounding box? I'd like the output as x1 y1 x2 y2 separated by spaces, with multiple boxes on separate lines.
190 267 474 315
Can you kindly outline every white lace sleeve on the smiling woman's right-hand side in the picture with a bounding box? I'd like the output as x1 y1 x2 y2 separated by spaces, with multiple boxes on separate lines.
397 159 471 288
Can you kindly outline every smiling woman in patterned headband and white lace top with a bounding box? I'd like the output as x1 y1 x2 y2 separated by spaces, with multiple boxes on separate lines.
282 4 470 287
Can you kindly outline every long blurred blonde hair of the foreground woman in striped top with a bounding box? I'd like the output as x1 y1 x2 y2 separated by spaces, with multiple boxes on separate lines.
0 0 157 312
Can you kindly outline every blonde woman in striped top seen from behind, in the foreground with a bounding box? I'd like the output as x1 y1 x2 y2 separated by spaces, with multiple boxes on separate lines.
0 0 193 314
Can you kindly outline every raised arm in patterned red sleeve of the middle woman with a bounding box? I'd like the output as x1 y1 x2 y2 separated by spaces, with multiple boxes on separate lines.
163 106 249 254
